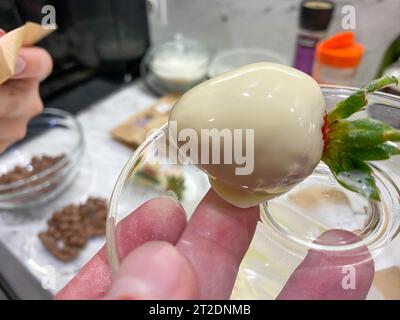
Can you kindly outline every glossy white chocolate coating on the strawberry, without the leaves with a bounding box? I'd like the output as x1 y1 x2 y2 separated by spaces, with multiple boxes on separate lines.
170 62 325 207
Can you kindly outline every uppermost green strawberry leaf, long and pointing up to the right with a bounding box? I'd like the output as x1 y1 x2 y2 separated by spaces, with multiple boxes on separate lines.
328 76 399 123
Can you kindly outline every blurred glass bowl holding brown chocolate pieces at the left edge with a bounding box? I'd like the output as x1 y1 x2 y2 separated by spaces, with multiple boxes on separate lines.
0 108 84 210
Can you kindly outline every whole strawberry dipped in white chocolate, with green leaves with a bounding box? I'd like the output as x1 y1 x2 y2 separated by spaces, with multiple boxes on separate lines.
169 62 400 208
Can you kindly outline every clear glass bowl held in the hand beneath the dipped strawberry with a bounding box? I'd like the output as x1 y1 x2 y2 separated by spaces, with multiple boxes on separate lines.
107 86 400 299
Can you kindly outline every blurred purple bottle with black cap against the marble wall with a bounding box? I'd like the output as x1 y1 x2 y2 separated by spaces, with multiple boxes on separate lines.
294 0 335 75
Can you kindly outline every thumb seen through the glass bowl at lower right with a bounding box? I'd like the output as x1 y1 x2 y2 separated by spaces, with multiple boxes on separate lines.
277 230 374 300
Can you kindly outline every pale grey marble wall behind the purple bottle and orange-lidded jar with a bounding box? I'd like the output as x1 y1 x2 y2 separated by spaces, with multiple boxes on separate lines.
149 0 400 84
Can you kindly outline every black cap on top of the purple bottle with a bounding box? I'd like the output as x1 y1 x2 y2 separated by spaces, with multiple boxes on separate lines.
300 0 335 31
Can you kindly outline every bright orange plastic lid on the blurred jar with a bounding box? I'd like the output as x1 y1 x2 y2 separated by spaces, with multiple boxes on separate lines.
316 31 364 68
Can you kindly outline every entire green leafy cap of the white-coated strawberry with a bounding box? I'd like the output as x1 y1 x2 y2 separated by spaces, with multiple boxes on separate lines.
322 76 400 201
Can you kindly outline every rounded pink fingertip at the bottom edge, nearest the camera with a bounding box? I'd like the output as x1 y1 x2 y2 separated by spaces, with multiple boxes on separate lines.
104 241 198 300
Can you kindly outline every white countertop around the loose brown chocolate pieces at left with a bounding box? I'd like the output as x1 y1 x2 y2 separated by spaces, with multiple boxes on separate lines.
0 81 156 292
